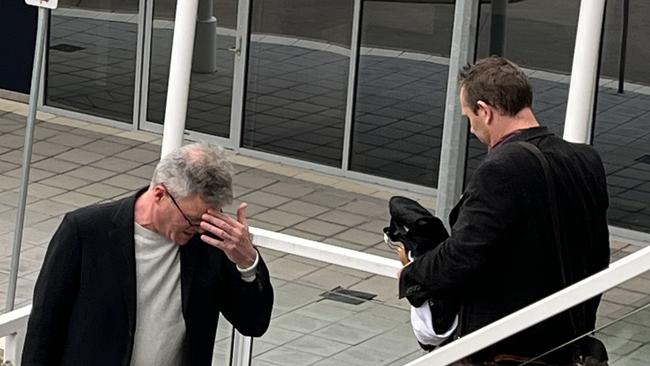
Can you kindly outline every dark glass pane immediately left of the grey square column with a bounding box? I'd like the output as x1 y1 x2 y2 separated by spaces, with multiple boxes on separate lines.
350 1 454 187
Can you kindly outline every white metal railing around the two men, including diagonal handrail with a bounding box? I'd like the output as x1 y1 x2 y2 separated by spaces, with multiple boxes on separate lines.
5 228 650 366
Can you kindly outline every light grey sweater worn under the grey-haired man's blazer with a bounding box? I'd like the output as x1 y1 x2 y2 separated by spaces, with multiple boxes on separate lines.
131 224 185 366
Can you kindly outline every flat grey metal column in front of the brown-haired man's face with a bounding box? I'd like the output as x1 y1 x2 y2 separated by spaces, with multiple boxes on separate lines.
436 0 479 226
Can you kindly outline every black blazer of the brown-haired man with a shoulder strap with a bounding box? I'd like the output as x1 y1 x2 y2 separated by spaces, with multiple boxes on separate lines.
400 127 609 358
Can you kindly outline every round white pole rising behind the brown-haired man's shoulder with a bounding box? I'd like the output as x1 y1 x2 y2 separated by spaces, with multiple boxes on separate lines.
564 0 605 143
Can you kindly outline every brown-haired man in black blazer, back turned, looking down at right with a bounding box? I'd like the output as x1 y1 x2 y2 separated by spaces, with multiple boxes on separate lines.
400 57 609 365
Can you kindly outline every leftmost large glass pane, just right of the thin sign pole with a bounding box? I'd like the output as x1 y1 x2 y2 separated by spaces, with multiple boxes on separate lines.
45 0 138 122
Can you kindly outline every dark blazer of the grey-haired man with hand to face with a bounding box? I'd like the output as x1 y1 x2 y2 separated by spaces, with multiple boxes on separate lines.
22 191 273 366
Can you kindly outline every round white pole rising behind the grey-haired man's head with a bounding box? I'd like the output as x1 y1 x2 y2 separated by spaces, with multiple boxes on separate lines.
160 0 199 156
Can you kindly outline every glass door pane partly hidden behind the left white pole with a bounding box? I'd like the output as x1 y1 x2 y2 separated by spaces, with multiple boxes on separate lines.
147 0 237 137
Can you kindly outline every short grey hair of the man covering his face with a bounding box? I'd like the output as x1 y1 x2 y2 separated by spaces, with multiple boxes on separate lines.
151 142 234 208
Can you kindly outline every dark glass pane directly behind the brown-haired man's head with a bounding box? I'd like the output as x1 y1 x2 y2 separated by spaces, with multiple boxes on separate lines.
465 0 579 182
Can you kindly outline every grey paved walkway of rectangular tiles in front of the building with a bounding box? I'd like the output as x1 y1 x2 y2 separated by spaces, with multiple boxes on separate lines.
0 100 650 366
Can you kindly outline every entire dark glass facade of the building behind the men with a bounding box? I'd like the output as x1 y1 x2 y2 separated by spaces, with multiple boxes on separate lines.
35 0 650 236
